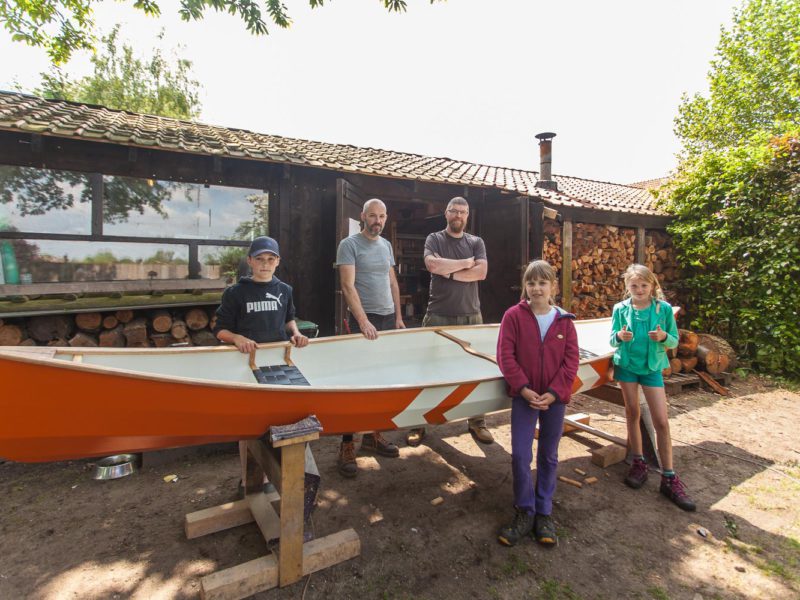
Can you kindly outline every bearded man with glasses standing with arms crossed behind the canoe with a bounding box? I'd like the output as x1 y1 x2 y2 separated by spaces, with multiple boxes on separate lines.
406 196 494 446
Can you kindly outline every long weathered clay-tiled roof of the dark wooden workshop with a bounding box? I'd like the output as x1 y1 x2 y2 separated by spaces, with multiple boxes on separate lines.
0 91 663 215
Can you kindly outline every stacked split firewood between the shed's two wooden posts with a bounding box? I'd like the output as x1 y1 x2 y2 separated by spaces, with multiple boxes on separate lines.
570 223 636 319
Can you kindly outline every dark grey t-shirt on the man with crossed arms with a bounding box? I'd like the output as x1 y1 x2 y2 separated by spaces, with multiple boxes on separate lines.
425 230 486 317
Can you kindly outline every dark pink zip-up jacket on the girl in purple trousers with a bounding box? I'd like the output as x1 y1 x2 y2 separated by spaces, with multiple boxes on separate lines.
497 300 580 404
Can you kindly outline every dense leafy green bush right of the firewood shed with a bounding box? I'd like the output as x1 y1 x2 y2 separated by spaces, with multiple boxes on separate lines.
664 130 800 379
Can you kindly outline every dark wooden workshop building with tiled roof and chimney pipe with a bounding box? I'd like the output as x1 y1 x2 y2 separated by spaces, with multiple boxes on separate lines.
0 92 678 342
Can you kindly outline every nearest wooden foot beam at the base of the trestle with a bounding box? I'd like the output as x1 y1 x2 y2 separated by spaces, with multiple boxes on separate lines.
200 529 361 600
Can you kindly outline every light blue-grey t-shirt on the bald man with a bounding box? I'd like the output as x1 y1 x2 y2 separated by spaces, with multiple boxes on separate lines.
336 233 394 315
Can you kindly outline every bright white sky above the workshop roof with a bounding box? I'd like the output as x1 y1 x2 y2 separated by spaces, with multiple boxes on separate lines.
0 0 741 183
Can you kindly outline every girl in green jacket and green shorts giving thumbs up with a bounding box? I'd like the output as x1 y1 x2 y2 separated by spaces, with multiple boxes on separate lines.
611 265 695 511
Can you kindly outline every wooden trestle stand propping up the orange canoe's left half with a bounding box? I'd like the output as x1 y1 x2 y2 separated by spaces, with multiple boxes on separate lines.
185 433 361 600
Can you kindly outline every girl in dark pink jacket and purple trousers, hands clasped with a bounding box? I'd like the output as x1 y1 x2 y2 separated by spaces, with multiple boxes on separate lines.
497 260 579 546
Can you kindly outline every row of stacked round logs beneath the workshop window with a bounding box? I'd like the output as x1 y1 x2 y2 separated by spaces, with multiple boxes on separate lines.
0 307 219 348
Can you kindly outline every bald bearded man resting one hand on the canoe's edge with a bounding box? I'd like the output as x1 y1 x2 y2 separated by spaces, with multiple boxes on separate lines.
336 198 405 477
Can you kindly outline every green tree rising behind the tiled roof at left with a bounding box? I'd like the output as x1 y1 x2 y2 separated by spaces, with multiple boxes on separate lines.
34 25 200 120
